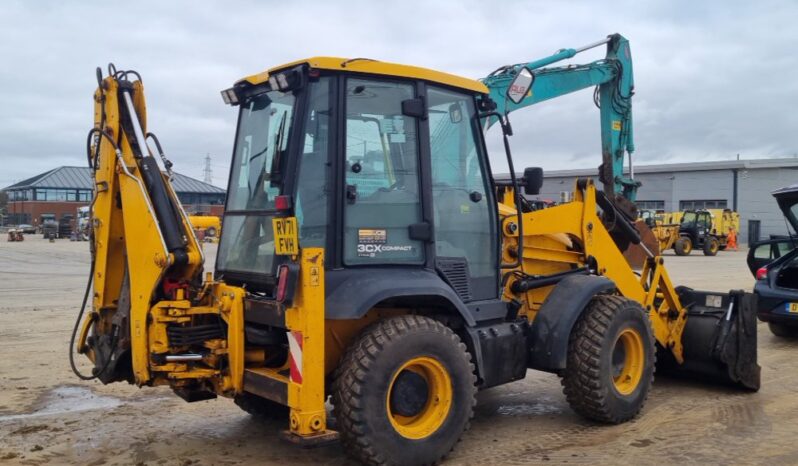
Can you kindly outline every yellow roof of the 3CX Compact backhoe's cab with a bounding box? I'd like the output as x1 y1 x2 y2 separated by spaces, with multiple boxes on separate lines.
239 57 488 94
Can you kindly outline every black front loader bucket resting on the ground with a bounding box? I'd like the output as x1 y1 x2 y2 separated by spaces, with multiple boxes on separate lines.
657 287 760 391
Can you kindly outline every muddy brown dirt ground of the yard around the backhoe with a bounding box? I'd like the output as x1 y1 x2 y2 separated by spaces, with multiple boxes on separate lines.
0 236 798 466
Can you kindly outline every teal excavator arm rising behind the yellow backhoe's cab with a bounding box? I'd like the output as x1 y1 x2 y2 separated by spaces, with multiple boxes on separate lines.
482 34 639 201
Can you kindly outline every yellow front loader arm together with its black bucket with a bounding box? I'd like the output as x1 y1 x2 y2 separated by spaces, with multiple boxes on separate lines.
500 179 759 390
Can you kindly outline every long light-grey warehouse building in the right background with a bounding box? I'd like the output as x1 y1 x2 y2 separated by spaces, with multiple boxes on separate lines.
537 158 798 244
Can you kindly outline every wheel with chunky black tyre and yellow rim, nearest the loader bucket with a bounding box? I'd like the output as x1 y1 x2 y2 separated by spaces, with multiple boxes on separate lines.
562 295 656 424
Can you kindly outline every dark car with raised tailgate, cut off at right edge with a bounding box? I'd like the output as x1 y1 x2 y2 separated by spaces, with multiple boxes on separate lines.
747 184 798 337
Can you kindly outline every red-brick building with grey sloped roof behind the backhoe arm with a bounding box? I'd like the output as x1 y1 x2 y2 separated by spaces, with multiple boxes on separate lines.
0 167 225 225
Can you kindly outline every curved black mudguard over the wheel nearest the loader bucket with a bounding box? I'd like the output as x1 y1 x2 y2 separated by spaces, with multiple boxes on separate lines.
529 275 615 372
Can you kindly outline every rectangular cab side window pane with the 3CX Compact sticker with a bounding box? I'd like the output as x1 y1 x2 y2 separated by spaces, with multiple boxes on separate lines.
343 78 426 265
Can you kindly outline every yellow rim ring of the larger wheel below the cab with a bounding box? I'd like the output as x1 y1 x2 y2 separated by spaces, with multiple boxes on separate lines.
385 356 453 440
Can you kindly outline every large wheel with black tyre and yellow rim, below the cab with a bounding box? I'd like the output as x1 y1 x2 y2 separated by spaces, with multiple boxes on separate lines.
332 315 476 465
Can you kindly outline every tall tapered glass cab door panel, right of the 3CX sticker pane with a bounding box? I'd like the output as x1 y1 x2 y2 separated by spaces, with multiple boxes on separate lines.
427 85 499 301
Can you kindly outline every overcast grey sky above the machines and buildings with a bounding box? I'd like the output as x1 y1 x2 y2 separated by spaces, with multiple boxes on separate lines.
0 0 798 187
